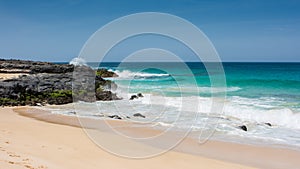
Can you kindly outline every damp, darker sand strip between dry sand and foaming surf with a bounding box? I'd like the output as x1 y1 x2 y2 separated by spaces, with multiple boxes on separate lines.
8 107 300 168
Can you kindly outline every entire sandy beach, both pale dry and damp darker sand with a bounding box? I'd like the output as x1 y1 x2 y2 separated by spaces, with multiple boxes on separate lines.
0 107 300 169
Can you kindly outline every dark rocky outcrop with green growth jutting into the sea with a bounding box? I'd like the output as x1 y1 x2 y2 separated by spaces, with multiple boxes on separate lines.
0 60 119 106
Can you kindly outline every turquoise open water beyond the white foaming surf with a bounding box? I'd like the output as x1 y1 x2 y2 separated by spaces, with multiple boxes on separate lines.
96 62 300 109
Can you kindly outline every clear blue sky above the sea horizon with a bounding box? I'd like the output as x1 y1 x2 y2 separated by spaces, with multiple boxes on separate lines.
0 0 300 62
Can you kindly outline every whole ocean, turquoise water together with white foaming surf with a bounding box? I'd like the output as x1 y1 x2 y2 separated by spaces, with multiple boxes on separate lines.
51 62 300 149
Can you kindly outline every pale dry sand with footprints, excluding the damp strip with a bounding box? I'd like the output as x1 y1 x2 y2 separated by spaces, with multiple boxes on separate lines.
0 107 253 169
